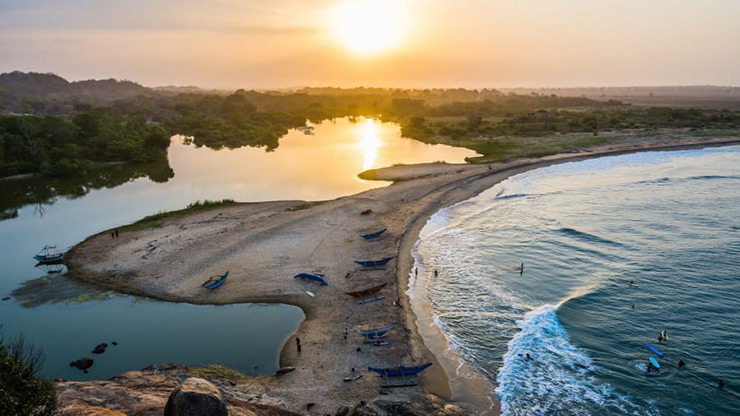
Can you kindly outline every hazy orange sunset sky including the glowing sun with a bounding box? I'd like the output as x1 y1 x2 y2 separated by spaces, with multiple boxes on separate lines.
0 0 740 88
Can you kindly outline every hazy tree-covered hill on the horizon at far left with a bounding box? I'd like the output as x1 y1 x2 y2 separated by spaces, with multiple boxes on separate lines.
0 71 153 114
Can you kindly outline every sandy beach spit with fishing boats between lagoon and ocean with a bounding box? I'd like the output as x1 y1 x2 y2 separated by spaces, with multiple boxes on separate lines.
66 138 740 414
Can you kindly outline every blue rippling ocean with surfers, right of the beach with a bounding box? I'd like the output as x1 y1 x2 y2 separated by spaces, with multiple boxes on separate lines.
410 147 740 415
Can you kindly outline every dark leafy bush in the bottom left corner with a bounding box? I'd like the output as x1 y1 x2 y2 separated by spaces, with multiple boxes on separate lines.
0 336 56 416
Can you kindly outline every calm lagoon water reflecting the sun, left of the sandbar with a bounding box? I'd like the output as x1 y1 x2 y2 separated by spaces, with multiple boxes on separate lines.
0 119 475 380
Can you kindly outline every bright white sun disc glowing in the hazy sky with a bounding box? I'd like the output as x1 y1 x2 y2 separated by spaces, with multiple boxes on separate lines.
329 0 408 55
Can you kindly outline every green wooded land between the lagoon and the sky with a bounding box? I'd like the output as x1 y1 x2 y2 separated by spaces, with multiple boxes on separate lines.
0 72 740 177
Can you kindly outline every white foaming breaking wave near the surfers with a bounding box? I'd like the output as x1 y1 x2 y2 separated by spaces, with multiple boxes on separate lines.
496 305 650 415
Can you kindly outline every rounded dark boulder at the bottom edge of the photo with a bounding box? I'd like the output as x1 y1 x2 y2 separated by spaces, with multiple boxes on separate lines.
164 377 229 416
